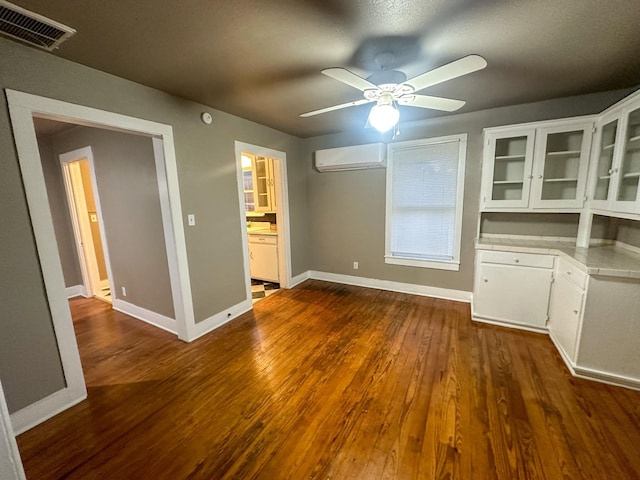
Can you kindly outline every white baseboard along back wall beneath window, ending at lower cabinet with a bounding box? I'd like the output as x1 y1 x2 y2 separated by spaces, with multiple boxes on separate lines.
308 270 471 303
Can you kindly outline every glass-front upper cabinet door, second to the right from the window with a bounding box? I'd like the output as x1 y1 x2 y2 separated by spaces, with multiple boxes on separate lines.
531 122 593 208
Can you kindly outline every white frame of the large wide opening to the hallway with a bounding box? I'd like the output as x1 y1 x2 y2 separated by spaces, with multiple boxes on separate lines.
5 89 198 434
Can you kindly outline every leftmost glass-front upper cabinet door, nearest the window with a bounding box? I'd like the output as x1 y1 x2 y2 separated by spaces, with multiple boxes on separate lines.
482 128 535 209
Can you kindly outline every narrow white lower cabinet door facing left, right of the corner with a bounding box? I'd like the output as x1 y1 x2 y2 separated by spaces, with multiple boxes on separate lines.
549 258 587 364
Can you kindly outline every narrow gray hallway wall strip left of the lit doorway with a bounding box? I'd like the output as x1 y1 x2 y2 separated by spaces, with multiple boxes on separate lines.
38 135 82 287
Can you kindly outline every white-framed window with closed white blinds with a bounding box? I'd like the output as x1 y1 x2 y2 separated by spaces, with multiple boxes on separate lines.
385 134 467 270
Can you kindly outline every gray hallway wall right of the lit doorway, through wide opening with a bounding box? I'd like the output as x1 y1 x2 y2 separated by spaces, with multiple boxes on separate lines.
49 127 175 318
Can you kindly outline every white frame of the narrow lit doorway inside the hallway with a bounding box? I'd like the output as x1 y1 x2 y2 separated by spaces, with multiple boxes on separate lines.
58 146 113 297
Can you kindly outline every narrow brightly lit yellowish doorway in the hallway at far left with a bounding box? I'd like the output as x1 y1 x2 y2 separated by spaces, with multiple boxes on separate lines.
59 147 113 303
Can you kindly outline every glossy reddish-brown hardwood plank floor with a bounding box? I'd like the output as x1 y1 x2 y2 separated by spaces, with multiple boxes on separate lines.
18 281 640 480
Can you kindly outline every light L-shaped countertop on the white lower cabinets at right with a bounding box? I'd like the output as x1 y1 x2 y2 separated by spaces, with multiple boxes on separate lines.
476 236 640 279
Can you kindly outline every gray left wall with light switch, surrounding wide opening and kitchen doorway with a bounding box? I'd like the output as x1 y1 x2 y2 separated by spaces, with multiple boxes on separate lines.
0 39 310 411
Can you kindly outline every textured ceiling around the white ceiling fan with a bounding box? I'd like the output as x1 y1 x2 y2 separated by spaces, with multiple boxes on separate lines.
8 0 640 137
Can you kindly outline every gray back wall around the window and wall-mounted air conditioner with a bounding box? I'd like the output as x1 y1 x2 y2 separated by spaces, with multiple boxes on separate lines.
305 90 629 291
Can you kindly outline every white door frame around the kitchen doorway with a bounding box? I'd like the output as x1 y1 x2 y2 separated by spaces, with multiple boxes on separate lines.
235 140 292 301
